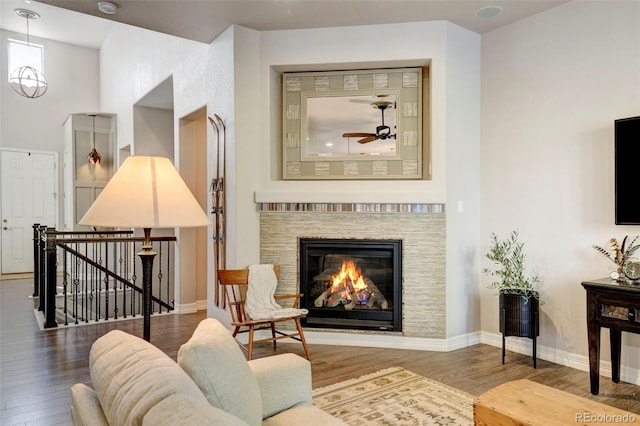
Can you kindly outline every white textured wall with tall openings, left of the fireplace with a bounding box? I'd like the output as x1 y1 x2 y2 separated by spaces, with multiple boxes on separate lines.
100 24 235 321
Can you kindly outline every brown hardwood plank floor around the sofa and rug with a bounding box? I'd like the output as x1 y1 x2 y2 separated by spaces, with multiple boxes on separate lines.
0 279 640 426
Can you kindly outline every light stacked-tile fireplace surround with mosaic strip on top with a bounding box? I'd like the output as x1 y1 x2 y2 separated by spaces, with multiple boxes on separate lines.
257 203 446 339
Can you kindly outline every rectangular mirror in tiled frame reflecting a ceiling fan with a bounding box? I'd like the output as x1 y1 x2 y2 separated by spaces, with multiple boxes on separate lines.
282 68 423 179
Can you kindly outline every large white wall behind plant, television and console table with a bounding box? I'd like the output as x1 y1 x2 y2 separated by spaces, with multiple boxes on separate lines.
481 1 640 376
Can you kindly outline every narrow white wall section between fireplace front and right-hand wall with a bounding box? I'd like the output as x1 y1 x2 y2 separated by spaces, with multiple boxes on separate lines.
444 26 481 337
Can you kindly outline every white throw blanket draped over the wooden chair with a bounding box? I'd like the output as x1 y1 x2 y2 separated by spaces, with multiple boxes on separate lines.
244 264 309 320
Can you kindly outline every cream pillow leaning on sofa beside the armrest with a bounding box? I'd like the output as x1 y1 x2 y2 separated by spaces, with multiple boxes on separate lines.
178 318 262 426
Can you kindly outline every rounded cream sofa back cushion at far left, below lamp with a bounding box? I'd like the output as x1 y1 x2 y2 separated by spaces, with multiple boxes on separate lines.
89 330 212 426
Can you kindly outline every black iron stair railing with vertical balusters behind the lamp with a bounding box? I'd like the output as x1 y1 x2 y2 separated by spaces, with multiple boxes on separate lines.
33 224 176 328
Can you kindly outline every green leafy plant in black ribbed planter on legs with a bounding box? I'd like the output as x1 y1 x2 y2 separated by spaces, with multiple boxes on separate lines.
483 231 540 368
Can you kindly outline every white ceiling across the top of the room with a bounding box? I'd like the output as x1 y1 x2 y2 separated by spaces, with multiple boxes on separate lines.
0 0 566 48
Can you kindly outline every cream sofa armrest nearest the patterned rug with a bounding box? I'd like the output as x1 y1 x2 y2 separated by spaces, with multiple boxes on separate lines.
249 354 312 419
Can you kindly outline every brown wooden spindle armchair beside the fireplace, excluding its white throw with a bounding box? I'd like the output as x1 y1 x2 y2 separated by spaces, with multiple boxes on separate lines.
218 265 311 360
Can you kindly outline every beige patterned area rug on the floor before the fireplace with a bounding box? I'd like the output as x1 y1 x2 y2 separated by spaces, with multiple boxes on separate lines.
313 367 474 426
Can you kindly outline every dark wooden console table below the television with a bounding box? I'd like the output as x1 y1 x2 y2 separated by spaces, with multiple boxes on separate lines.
582 278 640 395
